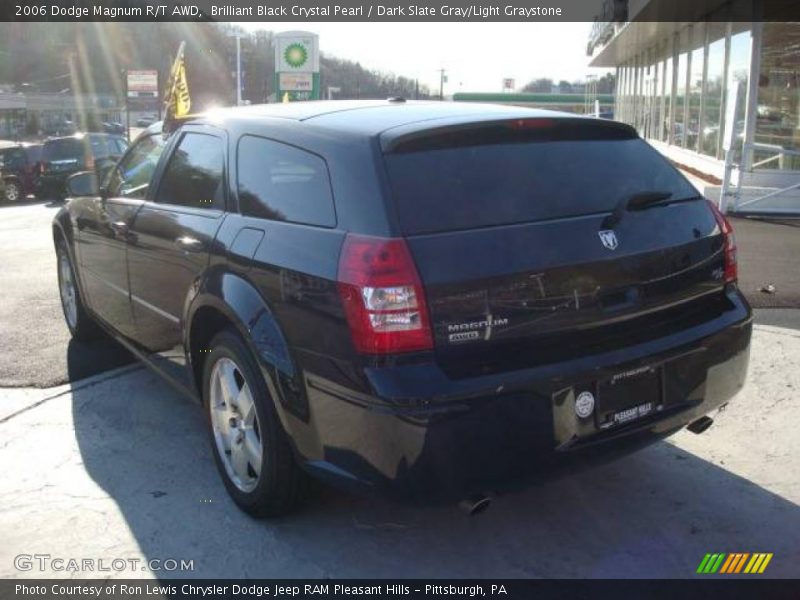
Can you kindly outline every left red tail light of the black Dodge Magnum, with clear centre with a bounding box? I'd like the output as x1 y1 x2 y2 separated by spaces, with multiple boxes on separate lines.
338 235 433 354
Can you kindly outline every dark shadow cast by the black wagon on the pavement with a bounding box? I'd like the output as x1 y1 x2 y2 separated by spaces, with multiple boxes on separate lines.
65 370 800 578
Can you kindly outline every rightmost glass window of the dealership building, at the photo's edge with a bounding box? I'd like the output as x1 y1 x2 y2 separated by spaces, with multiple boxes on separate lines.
753 22 800 169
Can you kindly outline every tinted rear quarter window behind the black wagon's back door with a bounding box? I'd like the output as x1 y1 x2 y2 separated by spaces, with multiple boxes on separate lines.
237 136 336 227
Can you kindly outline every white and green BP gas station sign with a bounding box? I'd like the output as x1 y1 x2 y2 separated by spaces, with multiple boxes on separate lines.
275 31 320 102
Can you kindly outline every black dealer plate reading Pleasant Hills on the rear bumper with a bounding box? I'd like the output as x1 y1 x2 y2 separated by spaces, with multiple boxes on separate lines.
595 367 662 429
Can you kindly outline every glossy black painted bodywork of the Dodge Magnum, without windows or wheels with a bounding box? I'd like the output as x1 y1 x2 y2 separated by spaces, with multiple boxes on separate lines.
54 103 752 496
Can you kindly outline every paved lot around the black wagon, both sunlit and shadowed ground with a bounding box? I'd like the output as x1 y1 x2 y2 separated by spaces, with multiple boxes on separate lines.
0 202 800 577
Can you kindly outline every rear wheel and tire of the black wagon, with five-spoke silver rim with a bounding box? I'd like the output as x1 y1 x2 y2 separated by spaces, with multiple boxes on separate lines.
203 329 306 518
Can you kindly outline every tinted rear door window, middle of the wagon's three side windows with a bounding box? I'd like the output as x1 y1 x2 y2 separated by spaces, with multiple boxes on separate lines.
156 133 225 210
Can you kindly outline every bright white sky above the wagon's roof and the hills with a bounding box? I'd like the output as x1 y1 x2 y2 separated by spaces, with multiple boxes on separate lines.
240 22 607 94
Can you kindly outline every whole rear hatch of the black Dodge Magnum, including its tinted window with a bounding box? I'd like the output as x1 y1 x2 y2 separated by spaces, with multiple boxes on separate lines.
384 118 731 377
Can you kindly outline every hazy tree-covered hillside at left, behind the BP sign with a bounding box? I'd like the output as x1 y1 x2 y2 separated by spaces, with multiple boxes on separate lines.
0 22 429 109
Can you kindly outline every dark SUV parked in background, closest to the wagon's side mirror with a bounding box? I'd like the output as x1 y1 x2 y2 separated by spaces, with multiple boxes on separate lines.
36 133 128 200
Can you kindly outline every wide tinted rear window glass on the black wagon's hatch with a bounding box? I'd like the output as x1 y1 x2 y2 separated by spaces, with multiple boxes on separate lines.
385 120 696 235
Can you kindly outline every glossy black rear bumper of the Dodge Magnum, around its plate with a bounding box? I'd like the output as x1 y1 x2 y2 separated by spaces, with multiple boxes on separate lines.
293 290 752 500
